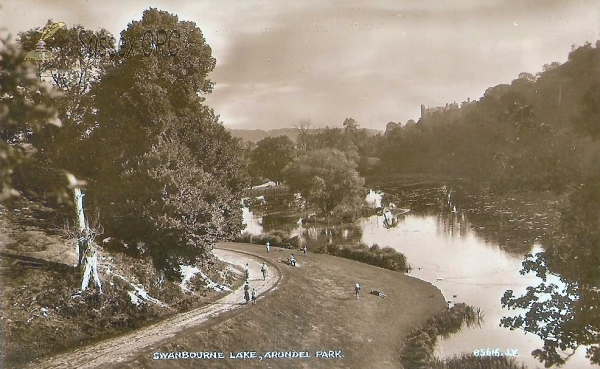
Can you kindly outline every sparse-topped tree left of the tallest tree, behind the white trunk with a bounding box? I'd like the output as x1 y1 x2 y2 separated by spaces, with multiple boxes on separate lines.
18 20 115 173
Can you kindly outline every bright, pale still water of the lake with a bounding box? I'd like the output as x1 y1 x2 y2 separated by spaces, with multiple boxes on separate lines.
244 188 592 369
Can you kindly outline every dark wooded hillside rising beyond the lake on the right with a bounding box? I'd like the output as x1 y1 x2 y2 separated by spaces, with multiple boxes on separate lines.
378 44 600 191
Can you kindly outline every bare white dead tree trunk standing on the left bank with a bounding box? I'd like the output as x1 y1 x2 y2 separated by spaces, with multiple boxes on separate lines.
73 187 102 293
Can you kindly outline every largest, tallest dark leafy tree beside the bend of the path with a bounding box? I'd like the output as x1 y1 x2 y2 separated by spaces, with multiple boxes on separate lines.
85 8 248 278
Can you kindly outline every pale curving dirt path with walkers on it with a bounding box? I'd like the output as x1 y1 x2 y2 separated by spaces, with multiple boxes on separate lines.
30 249 280 369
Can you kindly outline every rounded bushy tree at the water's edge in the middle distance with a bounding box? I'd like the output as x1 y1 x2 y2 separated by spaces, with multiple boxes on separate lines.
284 149 364 215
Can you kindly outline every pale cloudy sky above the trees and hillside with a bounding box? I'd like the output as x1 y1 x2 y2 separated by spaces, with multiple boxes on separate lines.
0 0 600 130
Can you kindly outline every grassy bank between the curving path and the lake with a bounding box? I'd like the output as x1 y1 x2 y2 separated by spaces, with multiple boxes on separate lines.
120 244 446 368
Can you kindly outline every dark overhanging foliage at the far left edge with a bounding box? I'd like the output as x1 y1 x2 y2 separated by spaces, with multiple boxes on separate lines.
0 38 61 200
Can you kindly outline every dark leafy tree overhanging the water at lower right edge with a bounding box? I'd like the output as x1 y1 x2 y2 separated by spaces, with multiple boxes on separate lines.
500 178 600 367
